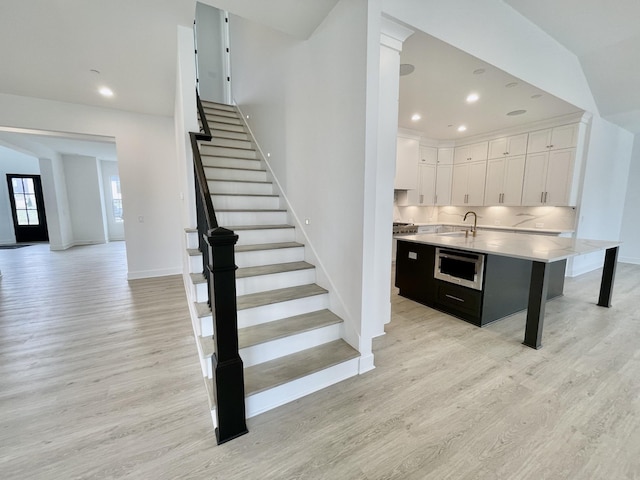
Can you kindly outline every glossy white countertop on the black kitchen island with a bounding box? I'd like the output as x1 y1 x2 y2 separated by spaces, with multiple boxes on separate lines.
397 230 620 263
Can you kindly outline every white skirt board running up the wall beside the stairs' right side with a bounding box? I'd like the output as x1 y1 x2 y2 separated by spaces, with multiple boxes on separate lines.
234 100 375 374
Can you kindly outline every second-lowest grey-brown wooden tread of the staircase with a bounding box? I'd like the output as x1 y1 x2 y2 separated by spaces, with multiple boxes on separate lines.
238 310 342 348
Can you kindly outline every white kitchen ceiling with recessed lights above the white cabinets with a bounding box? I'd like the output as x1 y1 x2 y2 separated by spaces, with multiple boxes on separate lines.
398 32 581 140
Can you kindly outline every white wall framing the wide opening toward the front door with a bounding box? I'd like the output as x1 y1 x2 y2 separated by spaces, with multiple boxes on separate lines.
0 94 182 278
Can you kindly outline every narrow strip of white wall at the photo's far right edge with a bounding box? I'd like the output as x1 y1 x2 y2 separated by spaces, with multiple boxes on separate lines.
618 135 640 264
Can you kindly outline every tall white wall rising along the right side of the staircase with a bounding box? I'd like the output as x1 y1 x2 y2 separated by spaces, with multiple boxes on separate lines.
230 0 374 356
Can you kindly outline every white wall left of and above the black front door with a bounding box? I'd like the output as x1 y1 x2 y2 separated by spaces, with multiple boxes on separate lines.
0 146 40 245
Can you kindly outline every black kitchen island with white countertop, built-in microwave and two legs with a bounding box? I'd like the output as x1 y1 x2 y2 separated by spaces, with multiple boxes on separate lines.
396 231 620 349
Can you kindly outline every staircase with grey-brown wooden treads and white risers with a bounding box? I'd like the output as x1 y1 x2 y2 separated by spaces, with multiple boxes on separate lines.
186 102 360 423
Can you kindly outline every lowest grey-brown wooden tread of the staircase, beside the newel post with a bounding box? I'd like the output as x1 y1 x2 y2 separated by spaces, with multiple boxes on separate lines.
244 340 360 395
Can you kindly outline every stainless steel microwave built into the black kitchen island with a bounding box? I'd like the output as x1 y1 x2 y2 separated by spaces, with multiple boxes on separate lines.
433 247 484 290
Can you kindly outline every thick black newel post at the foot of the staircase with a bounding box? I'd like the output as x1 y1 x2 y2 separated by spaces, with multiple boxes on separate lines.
207 227 248 444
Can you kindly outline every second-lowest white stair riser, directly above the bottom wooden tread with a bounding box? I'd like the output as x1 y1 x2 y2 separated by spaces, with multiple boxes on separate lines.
240 323 341 368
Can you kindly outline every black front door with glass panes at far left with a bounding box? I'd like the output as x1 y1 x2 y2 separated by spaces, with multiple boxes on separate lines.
7 174 49 243
